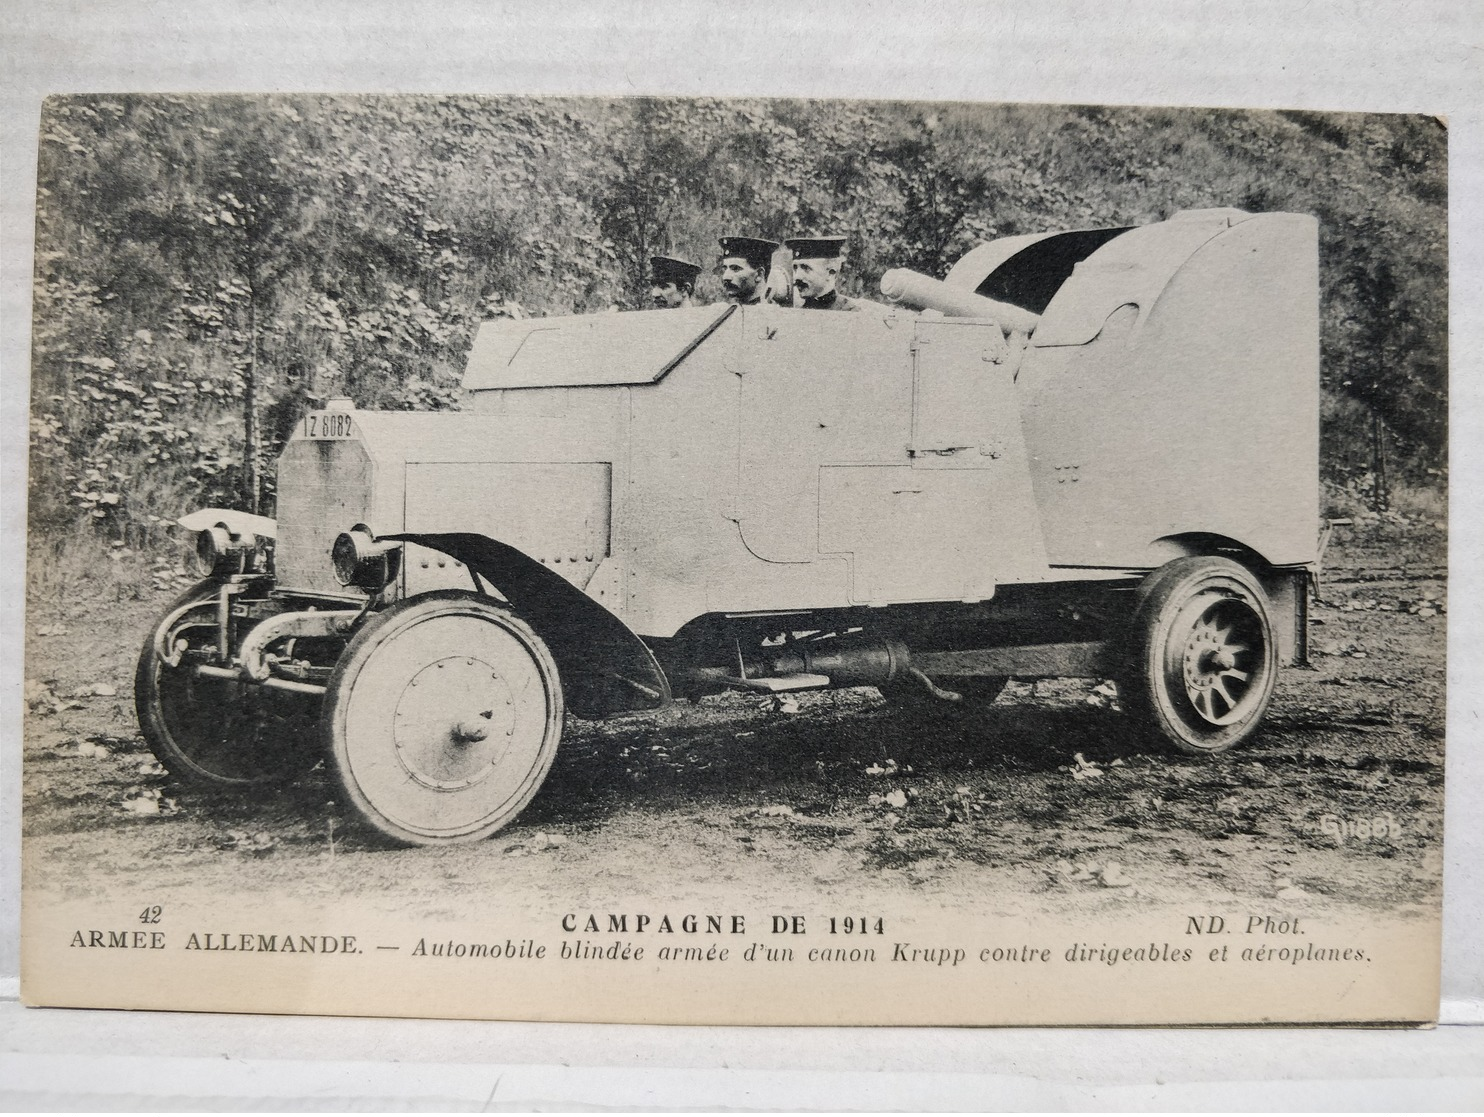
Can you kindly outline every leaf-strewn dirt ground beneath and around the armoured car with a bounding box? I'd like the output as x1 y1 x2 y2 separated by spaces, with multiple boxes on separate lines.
24 519 1445 918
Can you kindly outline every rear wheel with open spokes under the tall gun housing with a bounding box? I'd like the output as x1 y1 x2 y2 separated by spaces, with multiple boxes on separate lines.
1119 556 1278 755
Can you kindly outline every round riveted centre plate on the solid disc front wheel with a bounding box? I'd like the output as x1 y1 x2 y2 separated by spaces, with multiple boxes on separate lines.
392 656 515 791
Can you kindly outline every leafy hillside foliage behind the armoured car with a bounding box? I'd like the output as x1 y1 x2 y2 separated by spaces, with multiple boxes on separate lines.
31 95 1447 534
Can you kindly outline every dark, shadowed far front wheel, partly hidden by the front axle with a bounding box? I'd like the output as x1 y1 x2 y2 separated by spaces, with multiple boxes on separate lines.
134 581 319 788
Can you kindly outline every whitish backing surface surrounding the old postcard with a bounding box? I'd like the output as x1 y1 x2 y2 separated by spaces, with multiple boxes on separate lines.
0 0 1484 1108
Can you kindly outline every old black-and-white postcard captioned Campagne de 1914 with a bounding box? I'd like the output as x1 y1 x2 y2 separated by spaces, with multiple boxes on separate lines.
22 95 1448 1025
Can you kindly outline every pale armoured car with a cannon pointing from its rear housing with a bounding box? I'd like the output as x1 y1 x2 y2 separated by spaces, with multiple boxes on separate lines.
135 209 1319 843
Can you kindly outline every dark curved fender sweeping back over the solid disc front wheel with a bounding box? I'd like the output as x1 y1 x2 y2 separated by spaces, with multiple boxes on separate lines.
391 533 671 718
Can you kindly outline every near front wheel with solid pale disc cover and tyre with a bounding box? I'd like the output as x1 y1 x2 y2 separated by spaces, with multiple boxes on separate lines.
321 593 564 846
